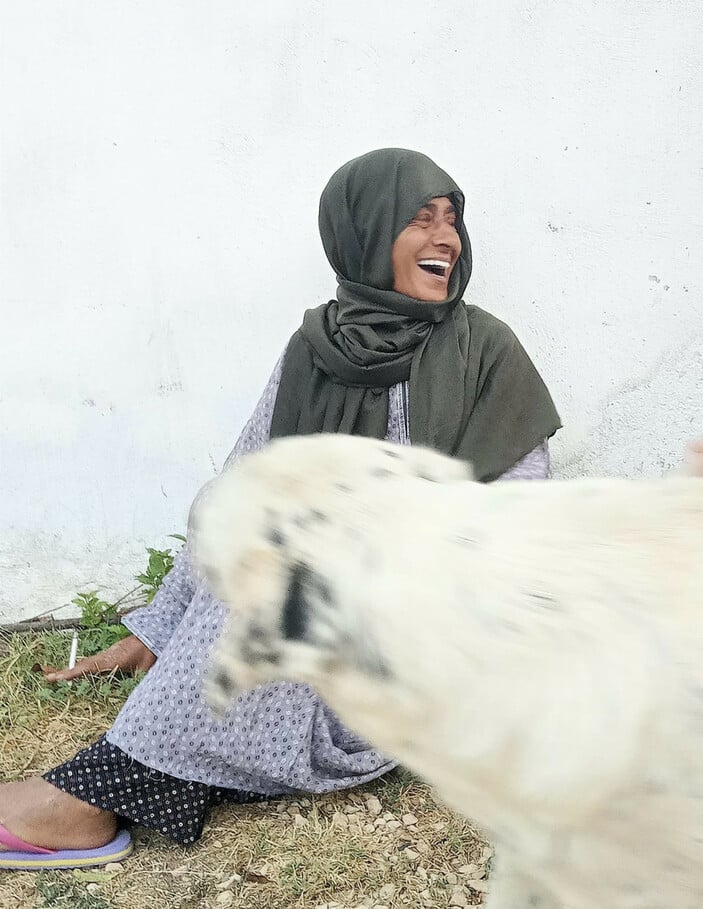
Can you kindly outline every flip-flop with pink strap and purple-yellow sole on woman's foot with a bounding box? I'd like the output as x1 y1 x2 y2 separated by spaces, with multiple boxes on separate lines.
0 824 132 871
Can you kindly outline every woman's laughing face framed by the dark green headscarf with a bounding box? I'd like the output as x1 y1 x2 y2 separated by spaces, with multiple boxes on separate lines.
392 196 461 303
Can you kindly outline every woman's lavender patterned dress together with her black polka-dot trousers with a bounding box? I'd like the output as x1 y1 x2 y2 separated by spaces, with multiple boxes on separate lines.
45 357 549 843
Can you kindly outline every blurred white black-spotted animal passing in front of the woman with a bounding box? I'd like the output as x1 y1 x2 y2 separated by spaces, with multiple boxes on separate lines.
193 435 703 909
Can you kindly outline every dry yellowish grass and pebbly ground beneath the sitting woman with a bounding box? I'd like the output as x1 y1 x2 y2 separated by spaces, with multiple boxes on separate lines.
0 636 491 909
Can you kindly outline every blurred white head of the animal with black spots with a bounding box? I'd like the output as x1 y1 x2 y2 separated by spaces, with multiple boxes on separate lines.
190 435 470 708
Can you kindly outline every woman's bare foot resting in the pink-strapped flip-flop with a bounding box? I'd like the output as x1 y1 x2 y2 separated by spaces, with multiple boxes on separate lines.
0 776 117 849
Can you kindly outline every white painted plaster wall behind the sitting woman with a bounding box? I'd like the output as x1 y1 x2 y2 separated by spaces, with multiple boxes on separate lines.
0 0 703 620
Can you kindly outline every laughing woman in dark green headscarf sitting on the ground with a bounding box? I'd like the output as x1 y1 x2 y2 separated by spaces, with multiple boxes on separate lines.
0 149 559 868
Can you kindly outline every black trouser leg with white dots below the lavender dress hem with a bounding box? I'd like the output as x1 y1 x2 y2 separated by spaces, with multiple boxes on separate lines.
44 736 266 846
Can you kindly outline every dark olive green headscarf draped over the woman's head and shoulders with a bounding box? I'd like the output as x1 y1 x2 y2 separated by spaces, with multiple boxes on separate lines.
271 148 560 481
